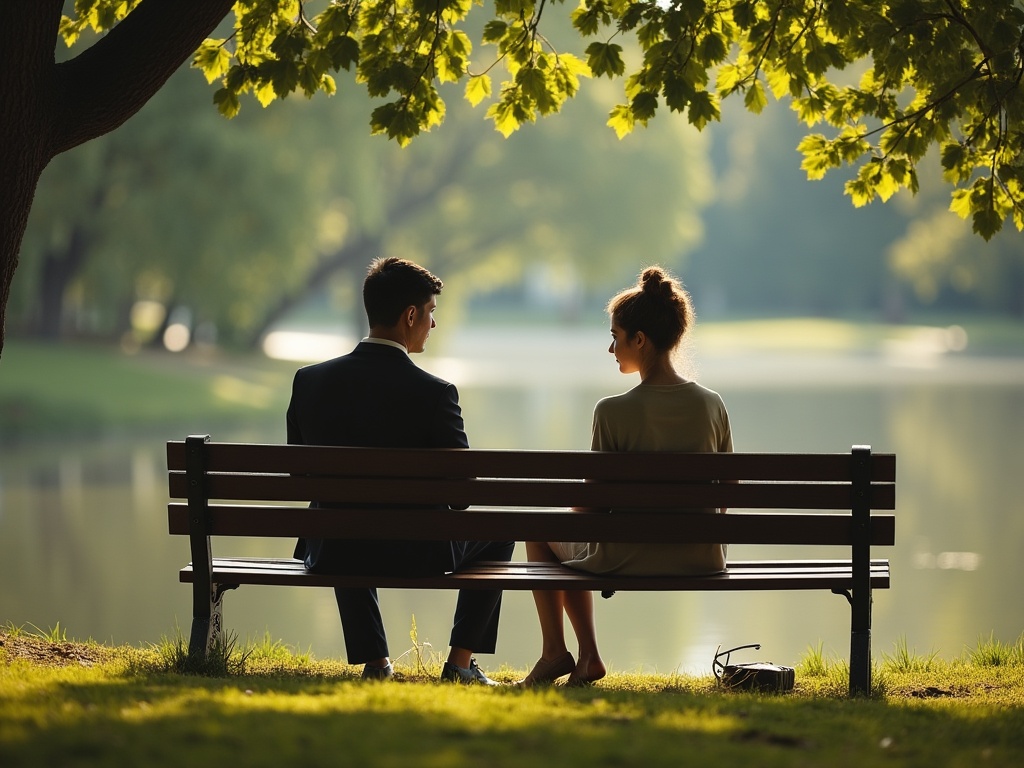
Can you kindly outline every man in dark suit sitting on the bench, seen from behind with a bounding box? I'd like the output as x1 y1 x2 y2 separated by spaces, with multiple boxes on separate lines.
288 258 515 685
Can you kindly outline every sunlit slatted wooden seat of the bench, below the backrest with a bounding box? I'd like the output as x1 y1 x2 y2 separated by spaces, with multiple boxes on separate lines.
179 558 889 592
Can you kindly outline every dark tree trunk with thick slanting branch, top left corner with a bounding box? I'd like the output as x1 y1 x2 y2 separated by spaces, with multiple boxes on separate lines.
0 0 233 355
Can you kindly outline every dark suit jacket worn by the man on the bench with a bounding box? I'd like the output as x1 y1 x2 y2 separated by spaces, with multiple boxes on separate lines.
288 342 469 574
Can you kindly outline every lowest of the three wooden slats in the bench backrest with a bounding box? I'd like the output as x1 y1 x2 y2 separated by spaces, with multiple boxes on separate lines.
168 503 896 546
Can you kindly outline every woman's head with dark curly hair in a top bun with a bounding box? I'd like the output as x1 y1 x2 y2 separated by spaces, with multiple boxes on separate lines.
607 266 694 352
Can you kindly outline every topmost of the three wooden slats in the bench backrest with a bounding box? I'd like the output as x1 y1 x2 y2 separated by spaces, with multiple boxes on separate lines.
167 440 896 482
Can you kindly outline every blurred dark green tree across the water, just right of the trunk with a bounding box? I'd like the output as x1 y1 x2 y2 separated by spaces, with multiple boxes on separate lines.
11 72 326 346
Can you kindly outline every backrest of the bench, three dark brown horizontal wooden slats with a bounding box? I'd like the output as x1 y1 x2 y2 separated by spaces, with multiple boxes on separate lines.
167 436 896 546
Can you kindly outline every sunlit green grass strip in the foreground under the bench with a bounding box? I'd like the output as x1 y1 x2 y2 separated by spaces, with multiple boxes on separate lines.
0 627 1024 768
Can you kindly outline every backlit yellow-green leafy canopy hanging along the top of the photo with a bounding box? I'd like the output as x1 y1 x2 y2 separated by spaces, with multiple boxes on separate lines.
63 0 1024 240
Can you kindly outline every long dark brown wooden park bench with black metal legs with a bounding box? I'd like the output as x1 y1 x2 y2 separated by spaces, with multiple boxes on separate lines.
167 435 896 695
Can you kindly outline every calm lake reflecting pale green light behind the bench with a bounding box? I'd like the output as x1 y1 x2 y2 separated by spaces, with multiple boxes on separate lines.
0 329 1024 674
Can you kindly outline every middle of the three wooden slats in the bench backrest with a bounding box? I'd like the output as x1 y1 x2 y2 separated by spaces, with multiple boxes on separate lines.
170 474 896 509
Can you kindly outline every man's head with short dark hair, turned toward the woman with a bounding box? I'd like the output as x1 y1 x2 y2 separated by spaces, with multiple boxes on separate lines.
362 256 444 352
